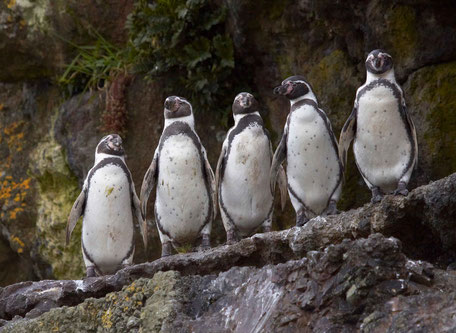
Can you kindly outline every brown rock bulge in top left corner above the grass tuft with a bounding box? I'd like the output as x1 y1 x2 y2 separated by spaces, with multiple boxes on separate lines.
0 0 133 82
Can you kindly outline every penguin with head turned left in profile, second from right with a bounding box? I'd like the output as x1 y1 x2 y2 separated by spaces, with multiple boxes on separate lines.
270 75 343 226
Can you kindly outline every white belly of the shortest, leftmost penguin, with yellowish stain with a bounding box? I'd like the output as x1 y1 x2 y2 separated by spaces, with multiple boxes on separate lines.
82 164 133 272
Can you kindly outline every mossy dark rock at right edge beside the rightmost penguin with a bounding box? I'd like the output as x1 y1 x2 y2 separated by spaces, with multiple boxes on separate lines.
406 62 456 179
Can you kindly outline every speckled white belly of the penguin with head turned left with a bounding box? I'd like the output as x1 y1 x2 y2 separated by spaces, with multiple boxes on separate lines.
287 105 341 215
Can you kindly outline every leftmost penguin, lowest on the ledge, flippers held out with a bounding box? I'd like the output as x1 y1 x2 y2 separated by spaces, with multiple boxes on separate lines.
66 134 147 277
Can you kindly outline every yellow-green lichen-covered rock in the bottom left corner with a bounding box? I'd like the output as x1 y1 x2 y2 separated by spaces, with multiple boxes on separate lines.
7 271 180 333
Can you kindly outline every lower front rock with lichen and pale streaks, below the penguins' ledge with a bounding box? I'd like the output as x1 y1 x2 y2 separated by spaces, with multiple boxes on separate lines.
2 234 456 332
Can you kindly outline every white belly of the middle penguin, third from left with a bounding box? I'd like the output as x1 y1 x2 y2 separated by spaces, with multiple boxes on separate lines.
220 124 273 234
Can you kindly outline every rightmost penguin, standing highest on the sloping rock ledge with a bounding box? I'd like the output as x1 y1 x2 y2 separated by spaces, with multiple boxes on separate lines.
339 50 418 203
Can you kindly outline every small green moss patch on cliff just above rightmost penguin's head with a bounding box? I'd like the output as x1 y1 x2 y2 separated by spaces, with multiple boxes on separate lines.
386 5 418 59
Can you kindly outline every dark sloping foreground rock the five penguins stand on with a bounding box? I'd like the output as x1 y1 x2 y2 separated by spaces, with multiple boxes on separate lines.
0 174 456 332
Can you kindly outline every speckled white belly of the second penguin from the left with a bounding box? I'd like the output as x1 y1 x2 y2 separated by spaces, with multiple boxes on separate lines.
155 134 209 242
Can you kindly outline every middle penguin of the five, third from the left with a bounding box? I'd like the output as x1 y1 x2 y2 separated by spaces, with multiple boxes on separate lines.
215 92 286 244
